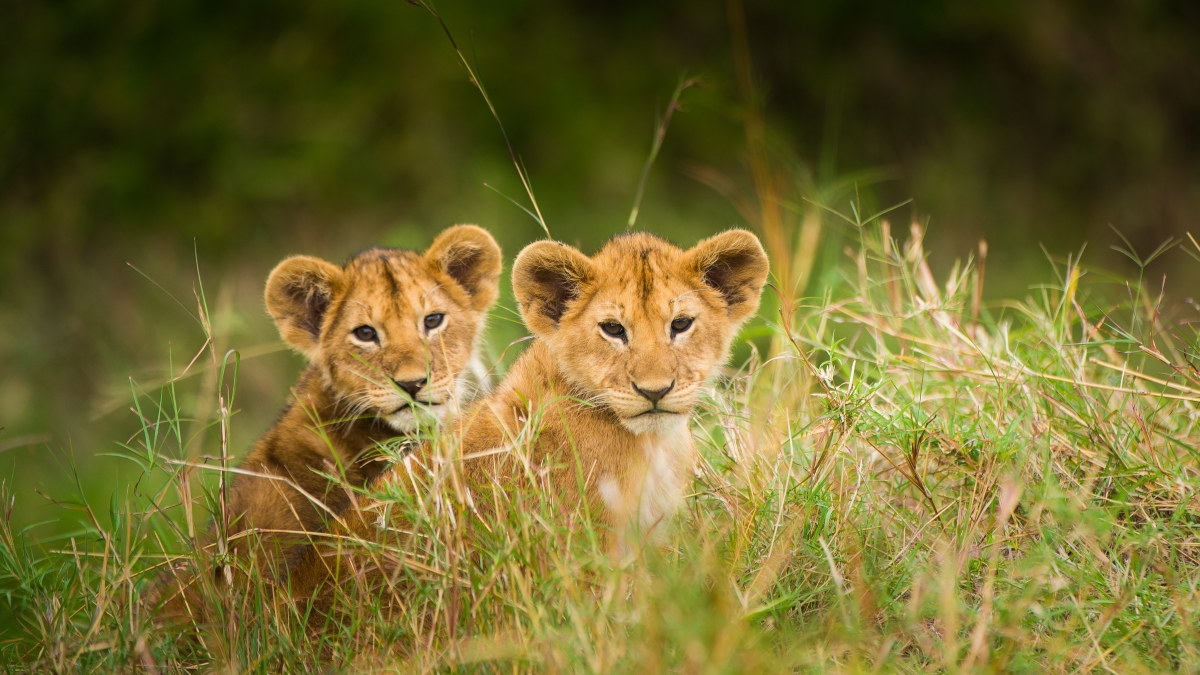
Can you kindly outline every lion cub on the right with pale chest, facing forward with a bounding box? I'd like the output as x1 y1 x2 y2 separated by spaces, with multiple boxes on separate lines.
290 229 769 597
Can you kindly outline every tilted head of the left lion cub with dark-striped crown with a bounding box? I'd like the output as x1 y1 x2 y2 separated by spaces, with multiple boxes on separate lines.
266 225 500 431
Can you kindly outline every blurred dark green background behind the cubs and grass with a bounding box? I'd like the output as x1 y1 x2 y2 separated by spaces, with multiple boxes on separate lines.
0 0 1200 520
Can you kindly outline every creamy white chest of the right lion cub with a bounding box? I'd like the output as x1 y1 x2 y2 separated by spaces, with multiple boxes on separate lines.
598 424 694 534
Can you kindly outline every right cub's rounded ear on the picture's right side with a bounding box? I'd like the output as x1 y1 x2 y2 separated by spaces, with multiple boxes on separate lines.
688 229 770 322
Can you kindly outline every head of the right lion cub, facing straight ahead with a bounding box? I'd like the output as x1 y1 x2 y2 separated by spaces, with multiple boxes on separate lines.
512 229 769 434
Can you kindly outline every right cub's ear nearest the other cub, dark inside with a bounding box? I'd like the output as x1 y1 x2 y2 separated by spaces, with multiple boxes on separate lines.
512 240 592 335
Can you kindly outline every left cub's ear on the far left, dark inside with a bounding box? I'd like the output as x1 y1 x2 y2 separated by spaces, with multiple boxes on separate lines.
266 256 342 358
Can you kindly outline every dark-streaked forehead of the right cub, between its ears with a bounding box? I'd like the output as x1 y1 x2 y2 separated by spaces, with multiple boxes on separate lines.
593 233 701 315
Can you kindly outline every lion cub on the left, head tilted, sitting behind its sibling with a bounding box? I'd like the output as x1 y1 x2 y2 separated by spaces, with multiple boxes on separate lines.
228 225 500 559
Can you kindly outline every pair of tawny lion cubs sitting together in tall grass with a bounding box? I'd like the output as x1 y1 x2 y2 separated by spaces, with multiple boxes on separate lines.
192 226 769 607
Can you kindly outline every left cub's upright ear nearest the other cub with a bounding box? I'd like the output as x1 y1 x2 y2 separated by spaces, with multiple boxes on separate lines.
425 225 500 311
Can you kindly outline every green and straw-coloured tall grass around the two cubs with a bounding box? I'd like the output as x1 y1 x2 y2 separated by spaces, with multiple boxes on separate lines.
0 222 1200 674
